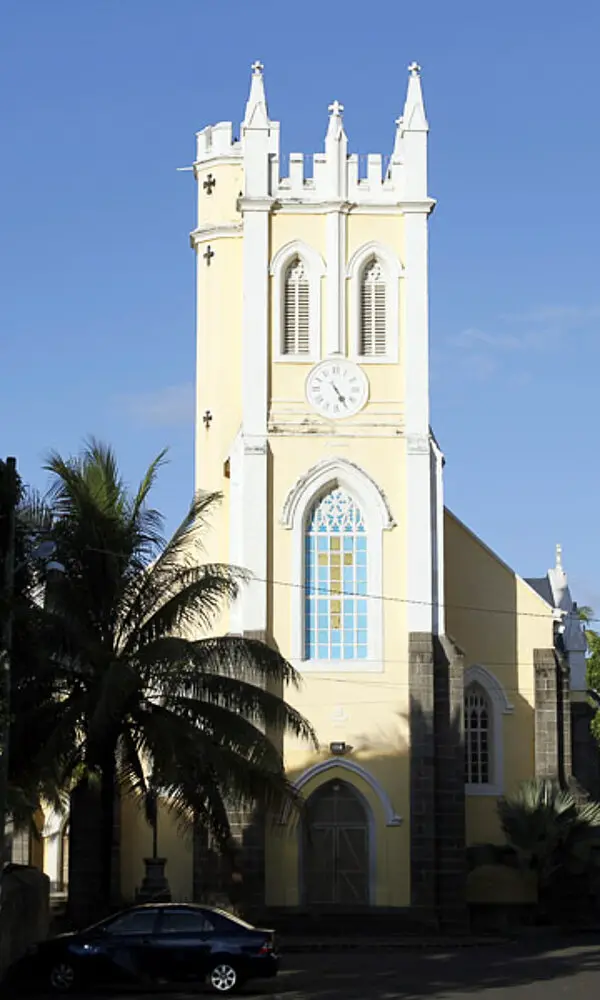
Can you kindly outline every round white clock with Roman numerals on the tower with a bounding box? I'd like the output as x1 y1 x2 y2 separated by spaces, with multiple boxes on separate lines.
306 358 369 420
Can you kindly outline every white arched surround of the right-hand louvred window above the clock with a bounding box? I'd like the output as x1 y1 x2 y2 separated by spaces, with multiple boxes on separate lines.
346 240 404 365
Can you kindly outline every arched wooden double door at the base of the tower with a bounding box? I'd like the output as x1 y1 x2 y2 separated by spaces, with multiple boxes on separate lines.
302 780 370 909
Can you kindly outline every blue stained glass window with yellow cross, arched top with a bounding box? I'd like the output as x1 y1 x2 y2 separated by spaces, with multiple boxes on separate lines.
304 487 368 660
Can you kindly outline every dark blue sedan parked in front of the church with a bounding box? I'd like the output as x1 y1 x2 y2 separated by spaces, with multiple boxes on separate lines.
5 903 279 994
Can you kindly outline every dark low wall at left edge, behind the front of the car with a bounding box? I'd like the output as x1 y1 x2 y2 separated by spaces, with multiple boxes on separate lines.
0 865 50 976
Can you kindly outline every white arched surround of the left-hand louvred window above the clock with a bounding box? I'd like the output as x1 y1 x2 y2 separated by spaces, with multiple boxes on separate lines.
269 240 326 364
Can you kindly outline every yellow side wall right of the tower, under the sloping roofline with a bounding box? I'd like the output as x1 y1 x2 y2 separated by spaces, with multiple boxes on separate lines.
444 511 553 856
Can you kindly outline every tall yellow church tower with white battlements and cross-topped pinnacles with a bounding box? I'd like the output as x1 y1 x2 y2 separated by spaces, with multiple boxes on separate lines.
191 62 452 920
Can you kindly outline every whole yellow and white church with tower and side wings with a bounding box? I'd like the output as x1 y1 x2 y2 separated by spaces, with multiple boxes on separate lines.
45 62 589 924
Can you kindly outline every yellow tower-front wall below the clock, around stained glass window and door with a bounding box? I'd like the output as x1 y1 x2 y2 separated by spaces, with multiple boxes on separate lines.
267 435 410 906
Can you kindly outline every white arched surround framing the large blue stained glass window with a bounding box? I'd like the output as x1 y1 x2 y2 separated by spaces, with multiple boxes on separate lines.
281 458 396 673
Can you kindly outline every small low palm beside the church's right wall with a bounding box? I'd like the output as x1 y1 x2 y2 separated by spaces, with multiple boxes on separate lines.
498 778 600 903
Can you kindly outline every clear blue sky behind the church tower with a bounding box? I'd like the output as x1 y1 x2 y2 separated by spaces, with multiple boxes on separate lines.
0 0 600 612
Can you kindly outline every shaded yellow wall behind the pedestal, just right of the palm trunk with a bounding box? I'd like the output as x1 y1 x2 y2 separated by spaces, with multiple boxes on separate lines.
121 795 193 902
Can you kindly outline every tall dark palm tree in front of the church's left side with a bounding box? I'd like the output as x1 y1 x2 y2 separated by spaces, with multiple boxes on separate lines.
39 440 315 916
